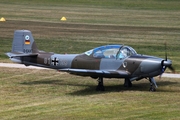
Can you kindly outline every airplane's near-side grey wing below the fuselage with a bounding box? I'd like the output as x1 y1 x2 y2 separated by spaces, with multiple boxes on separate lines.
59 69 130 78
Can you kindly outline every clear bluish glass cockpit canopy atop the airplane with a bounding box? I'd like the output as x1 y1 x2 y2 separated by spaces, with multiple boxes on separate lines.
85 45 137 59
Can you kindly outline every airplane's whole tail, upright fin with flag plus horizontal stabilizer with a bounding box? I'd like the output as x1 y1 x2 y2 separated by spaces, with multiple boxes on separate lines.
6 30 38 63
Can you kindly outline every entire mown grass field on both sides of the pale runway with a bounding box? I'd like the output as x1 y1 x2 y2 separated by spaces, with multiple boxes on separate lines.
0 0 180 120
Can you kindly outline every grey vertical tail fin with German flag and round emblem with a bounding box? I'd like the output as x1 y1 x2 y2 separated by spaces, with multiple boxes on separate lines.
11 30 38 54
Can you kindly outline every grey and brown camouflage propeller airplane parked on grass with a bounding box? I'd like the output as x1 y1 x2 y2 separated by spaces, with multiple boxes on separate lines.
6 30 174 92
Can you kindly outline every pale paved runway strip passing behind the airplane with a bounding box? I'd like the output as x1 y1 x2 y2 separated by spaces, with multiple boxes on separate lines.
0 63 180 78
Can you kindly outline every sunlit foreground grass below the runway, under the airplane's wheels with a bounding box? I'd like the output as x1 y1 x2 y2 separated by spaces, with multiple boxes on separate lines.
0 68 180 120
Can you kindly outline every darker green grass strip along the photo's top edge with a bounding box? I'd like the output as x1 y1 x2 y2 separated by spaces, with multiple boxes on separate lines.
2 0 180 10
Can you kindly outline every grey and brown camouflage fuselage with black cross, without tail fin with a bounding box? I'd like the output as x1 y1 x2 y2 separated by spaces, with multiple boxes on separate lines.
18 52 167 79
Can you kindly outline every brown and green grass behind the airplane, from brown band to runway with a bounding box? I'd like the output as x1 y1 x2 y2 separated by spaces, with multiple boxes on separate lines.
0 20 180 72
